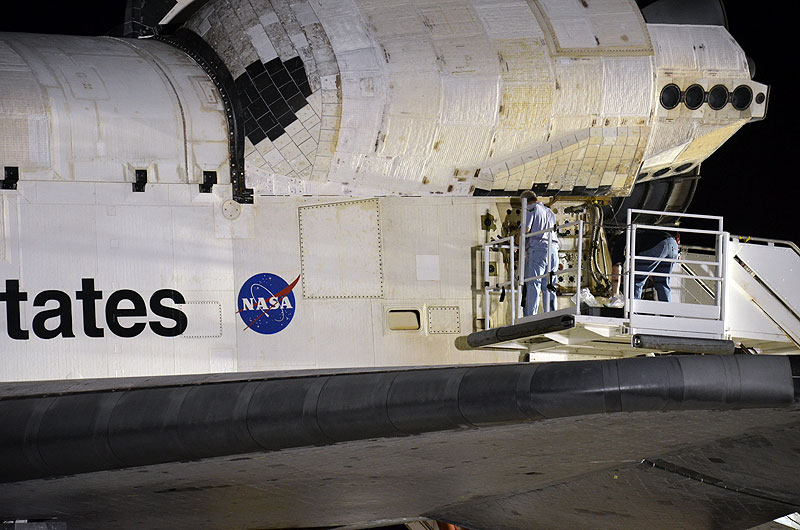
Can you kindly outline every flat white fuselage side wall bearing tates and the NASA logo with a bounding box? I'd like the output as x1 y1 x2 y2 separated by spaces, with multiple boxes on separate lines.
0 188 517 381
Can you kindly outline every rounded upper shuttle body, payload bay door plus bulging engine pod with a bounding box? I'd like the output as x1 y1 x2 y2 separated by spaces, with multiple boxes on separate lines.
0 0 767 198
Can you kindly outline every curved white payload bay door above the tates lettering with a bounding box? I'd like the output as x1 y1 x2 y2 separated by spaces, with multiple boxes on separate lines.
0 33 229 183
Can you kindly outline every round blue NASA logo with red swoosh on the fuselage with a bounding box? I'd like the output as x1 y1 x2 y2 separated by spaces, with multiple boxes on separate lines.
237 272 300 335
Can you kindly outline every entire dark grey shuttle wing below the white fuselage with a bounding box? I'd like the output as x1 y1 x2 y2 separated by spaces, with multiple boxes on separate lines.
0 355 800 529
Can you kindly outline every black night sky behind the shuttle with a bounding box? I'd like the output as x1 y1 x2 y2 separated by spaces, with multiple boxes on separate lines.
0 0 800 243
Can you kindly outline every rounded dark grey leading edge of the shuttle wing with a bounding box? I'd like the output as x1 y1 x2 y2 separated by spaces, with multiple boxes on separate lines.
0 355 800 483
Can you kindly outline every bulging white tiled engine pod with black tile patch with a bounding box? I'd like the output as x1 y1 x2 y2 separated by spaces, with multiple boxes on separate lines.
172 0 765 197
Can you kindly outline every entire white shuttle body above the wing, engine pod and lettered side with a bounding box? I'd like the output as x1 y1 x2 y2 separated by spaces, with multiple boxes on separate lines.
0 0 768 380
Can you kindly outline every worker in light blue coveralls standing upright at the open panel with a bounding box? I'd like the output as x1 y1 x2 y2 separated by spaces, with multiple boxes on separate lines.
522 191 558 316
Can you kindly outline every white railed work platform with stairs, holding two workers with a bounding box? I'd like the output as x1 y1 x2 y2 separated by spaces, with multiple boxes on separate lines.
466 210 800 358
